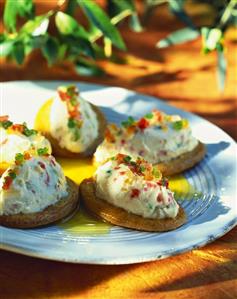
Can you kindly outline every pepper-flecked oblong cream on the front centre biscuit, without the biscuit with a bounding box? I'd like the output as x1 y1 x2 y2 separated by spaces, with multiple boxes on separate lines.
95 156 179 219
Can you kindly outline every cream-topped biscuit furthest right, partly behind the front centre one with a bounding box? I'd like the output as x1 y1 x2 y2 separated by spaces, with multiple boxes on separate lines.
94 110 205 175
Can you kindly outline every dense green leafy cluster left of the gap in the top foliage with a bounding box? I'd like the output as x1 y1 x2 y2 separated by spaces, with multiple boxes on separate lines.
0 0 141 76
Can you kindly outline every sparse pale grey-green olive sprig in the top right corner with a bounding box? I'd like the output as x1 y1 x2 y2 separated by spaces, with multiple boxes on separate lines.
147 0 237 90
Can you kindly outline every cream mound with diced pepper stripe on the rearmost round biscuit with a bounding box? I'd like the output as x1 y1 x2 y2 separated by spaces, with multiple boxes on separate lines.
50 86 99 153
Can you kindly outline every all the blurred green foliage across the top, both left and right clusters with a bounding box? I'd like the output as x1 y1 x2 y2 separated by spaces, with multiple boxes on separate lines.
0 0 237 89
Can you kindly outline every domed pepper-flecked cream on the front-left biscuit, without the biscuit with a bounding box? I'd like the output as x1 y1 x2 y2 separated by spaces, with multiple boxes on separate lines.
0 153 68 215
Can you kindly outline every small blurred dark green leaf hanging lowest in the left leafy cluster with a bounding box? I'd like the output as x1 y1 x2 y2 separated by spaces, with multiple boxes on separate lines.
75 58 104 76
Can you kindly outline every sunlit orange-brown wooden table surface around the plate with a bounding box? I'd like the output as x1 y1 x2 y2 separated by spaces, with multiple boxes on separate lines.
0 1 237 299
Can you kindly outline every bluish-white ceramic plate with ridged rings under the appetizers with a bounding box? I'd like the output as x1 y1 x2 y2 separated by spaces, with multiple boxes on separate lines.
0 81 237 264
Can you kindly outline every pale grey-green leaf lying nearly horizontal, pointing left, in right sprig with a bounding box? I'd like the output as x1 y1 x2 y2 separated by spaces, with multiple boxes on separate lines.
156 27 200 48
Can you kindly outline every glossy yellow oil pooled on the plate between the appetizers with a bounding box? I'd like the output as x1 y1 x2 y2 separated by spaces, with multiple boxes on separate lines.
57 158 200 236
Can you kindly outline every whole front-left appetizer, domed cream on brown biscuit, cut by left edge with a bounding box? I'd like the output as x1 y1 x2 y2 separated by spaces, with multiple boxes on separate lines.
0 148 79 228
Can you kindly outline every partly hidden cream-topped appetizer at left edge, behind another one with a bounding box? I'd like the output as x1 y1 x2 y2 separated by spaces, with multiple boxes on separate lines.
0 115 51 174
